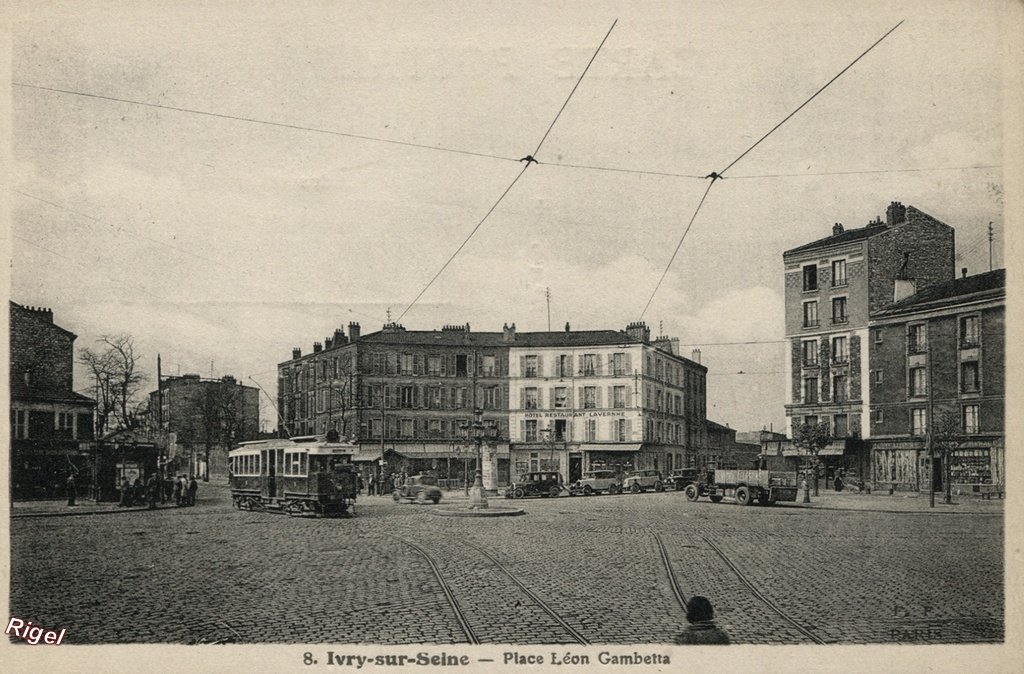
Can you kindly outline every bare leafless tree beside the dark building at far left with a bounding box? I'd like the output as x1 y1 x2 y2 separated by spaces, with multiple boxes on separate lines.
78 334 146 434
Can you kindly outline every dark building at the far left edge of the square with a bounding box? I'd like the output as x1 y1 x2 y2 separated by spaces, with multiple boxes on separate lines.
9 302 96 499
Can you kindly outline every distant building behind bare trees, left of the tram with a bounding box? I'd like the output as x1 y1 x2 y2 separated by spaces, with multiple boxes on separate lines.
150 374 259 479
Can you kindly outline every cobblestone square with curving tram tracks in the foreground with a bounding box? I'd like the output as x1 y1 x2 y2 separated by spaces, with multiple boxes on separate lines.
10 487 1004 644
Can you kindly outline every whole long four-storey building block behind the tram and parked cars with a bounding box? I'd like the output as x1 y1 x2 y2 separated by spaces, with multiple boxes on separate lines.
278 323 707 489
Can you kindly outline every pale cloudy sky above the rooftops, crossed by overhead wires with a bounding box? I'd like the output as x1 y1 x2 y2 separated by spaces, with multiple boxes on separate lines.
9 2 1019 429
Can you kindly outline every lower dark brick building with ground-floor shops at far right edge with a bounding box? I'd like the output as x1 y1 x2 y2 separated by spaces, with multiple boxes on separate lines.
868 269 1006 492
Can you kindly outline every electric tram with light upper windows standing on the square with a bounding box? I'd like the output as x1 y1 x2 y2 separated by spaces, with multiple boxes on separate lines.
227 435 358 517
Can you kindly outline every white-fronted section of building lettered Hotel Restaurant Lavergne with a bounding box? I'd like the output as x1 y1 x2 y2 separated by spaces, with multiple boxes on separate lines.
506 323 707 481
